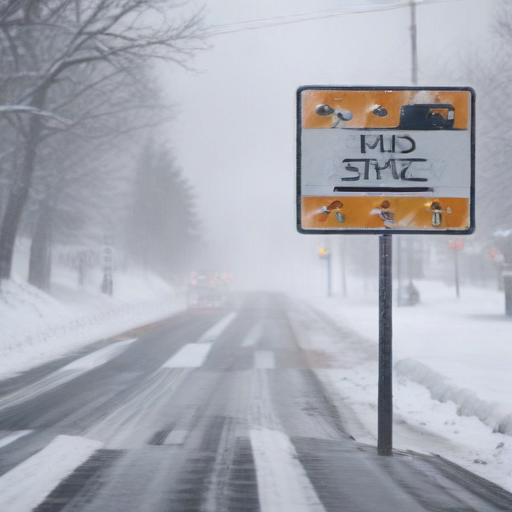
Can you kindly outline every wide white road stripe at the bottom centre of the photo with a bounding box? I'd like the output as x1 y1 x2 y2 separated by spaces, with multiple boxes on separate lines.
250 429 325 512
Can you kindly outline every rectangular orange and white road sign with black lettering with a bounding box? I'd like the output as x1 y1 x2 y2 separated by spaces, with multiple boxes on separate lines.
297 86 475 234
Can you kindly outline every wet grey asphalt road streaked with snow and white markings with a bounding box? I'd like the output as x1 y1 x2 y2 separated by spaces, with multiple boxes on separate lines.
0 294 512 512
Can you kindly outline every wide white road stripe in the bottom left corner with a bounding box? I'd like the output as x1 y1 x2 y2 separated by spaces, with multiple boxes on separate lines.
0 436 103 512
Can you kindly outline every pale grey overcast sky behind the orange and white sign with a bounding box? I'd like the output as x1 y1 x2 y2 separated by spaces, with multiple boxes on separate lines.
162 0 497 289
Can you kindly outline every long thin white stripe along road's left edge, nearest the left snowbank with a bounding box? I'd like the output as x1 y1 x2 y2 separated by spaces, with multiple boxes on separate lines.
0 338 137 409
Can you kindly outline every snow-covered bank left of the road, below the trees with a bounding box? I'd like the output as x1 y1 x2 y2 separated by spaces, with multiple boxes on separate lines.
0 242 184 378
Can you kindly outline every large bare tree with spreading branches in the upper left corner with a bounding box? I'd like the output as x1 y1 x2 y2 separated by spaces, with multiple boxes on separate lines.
0 0 203 278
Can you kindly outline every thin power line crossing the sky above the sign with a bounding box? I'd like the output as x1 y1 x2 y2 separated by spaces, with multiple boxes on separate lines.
207 0 463 36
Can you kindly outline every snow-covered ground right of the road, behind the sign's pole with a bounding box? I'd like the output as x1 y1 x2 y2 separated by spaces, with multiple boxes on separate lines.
299 281 512 491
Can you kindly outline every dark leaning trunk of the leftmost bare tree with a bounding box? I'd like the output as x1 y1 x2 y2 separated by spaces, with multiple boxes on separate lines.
0 91 46 279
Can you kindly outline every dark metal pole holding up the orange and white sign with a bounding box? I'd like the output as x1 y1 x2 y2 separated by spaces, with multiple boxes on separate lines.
377 235 393 455
